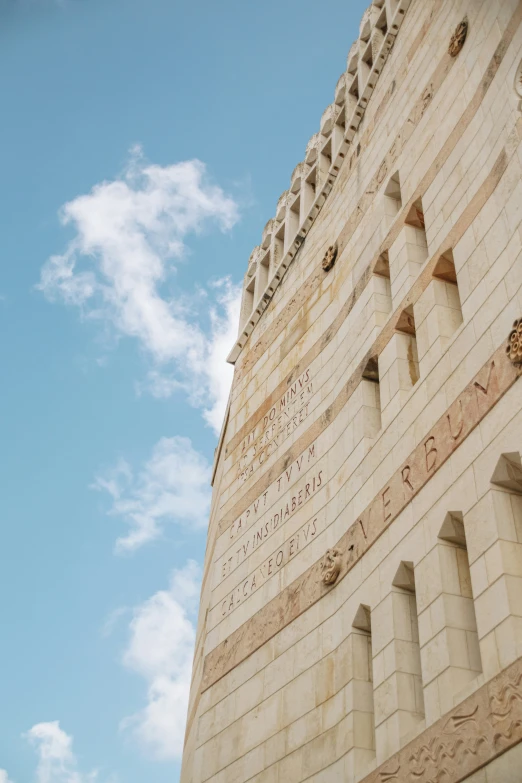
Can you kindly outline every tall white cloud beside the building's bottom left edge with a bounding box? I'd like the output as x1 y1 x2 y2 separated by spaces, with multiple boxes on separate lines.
122 561 200 759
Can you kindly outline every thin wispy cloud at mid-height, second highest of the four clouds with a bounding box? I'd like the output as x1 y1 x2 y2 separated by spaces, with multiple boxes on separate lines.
92 436 211 552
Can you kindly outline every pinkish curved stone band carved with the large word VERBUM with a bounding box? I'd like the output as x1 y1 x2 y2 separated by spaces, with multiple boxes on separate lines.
203 346 522 690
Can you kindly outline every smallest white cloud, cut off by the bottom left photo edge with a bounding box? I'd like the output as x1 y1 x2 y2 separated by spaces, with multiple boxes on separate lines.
23 721 98 783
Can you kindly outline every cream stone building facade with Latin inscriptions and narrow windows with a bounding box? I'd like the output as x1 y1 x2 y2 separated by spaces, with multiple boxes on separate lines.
181 0 522 783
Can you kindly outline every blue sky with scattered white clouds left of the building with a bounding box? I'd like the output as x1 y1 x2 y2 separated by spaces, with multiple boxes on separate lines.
0 0 365 783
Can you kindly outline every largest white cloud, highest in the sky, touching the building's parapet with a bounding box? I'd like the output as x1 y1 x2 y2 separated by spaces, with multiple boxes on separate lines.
38 147 239 430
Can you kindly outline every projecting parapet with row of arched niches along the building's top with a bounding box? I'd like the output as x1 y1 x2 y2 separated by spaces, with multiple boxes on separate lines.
228 0 411 364
